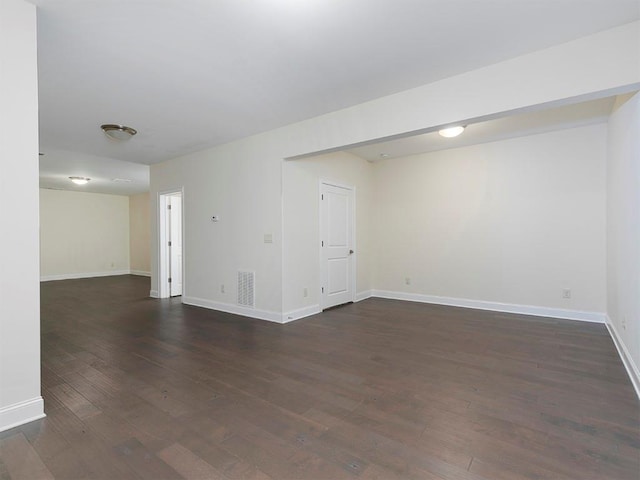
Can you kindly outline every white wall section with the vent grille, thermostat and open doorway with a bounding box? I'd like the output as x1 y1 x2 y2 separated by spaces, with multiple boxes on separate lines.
151 145 282 321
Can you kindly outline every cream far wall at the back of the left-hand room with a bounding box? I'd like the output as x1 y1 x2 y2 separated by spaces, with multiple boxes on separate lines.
40 189 129 280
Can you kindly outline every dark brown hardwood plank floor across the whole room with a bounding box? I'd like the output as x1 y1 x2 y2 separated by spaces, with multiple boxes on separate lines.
0 276 640 480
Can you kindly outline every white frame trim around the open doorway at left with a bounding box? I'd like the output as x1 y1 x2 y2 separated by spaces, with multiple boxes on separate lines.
157 187 186 299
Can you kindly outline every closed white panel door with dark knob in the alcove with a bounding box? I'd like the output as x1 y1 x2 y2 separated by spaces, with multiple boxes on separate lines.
320 183 355 309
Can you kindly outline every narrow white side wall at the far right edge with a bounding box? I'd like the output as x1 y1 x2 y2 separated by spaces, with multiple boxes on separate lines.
607 94 640 396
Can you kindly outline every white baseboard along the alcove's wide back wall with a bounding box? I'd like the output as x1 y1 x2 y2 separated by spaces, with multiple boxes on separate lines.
372 290 605 323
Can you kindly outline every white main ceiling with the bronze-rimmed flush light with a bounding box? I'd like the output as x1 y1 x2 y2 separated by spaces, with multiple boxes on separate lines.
32 0 640 194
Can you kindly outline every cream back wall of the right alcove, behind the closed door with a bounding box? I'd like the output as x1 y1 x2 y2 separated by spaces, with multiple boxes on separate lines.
374 124 606 319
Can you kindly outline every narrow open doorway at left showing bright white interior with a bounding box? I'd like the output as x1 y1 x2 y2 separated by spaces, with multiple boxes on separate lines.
158 190 184 298
